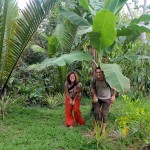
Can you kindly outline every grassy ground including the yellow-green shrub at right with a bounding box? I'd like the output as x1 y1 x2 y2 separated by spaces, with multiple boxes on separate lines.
0 96 150 150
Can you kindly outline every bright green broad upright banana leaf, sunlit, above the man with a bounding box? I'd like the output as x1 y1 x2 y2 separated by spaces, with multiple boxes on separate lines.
90 10 117 52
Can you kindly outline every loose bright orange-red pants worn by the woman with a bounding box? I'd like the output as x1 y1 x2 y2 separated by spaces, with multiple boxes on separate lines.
65 96 85 126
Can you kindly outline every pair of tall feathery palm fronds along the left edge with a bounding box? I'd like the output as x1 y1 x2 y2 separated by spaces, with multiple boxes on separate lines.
0 0 56 98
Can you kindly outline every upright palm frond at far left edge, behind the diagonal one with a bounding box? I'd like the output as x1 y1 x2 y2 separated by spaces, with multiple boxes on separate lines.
0 0 18 81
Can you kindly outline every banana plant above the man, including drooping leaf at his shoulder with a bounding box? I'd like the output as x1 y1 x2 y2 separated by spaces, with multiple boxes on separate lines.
57 0 149 91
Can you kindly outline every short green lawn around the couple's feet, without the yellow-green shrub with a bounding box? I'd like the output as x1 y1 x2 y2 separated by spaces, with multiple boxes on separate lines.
0 96 150 150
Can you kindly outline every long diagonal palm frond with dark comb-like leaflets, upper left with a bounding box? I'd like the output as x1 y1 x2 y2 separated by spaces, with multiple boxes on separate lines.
0 0 56 91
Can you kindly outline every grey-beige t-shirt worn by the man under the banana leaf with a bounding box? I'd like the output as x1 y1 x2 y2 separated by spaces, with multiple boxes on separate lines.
91 78 111 100
